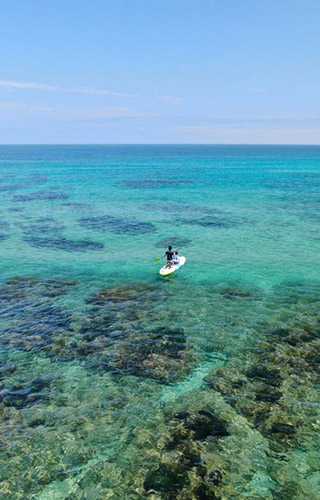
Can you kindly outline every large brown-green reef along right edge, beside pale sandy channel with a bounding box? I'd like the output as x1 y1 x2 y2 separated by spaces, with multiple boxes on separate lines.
206 282 320 453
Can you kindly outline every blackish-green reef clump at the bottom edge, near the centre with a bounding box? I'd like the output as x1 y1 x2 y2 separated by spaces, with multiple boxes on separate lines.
143 407 229 500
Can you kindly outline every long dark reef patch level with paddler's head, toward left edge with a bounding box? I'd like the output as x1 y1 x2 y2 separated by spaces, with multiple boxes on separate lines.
23 236 104 252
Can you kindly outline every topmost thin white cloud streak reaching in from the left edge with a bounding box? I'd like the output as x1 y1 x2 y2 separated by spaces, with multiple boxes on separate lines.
0 79 138 97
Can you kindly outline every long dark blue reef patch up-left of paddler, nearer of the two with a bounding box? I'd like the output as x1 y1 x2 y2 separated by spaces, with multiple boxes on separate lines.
78 215 156 235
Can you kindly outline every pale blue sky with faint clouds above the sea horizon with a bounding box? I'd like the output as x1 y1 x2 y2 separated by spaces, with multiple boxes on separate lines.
0 0 320 144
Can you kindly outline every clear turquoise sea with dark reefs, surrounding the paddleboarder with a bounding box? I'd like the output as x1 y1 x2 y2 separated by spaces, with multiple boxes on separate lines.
0 146 320 500
